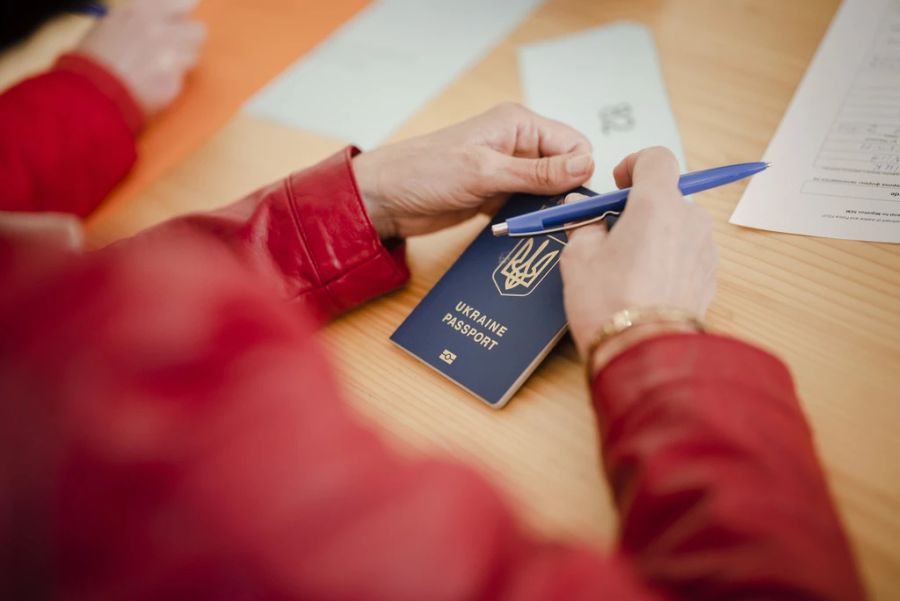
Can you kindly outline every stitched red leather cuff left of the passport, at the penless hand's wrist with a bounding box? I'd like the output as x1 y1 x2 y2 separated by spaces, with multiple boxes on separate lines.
286 146 409 316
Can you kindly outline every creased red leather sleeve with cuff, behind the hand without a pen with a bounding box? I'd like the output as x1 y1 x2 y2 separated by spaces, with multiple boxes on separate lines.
128 147 409 321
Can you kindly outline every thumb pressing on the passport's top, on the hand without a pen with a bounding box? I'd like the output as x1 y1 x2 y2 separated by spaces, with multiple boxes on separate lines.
494 153 594 194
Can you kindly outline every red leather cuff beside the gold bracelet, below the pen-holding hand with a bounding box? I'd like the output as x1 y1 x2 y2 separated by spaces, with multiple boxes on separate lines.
592 334 795 432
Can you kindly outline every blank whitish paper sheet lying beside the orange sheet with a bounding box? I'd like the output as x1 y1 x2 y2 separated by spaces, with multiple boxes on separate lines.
246 0 541 147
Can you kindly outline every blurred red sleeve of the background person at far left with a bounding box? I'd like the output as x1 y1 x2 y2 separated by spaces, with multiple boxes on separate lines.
0 56 139 216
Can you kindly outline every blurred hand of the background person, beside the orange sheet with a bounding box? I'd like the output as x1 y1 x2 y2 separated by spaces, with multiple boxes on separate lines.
77 0 206 115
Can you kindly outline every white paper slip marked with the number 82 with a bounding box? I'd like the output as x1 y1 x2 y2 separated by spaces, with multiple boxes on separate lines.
519 22 685 192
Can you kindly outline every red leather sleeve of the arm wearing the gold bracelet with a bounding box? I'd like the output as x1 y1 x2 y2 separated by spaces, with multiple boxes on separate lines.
594 335 864 601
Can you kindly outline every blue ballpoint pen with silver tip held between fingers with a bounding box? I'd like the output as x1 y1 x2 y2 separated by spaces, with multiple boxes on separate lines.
491 163 769 237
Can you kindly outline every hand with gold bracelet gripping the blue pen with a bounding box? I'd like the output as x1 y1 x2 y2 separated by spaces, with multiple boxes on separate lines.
560 148 717 367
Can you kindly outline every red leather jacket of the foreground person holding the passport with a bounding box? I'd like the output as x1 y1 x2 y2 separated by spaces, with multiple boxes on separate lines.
0 59 863 601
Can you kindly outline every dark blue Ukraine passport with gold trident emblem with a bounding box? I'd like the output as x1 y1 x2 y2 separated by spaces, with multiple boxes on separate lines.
391 188 593 408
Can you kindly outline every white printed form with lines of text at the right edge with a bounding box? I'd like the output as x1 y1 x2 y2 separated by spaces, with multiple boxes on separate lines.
731 0 900 242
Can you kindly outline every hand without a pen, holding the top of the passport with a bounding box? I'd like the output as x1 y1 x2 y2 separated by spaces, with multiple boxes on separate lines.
353 103 594 238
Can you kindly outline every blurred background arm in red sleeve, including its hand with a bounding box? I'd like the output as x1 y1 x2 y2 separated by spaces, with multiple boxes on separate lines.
0 0 205 216
